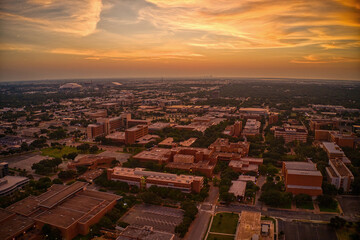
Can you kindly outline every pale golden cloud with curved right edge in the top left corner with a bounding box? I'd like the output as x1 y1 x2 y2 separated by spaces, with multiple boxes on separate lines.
0 0 102 36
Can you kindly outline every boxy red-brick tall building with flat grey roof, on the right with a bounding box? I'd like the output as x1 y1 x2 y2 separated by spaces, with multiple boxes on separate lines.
282 162 323 196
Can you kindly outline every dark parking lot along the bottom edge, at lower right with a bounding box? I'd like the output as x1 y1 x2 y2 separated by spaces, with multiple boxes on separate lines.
278 220 337 240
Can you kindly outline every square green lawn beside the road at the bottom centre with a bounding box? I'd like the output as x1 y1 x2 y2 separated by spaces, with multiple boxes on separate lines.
210 213 239 234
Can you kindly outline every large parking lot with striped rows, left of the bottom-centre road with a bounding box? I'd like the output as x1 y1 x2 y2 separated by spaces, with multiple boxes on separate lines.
121 204 183 233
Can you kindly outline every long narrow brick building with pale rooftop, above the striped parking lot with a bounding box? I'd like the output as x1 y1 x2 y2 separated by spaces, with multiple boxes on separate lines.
107 167 204 193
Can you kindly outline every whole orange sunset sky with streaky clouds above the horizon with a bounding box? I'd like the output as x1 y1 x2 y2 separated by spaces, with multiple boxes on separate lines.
0 0 360 81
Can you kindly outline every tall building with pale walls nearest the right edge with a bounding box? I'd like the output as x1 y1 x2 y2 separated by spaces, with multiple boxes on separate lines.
326 158 354 192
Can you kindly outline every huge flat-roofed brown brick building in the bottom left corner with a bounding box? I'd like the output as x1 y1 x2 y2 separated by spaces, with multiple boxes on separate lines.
6 182 121 240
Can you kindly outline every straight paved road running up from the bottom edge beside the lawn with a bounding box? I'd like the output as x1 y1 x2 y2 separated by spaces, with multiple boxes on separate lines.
184 183 219 240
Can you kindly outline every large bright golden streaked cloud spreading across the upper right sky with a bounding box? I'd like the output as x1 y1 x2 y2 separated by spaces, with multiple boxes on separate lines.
139 0 360 50
